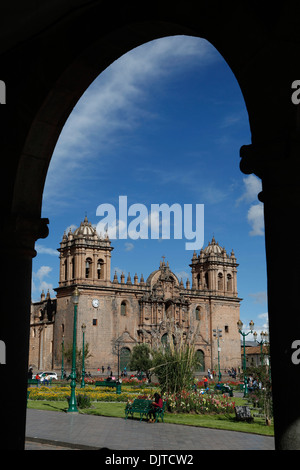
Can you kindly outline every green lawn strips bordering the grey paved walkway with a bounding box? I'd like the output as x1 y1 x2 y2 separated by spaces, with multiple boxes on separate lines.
28 398 274 436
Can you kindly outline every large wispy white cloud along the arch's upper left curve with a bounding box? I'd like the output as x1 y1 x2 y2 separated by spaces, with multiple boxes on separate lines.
44 36 220 203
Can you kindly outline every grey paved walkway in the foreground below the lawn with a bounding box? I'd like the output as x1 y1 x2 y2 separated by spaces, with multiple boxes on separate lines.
25 409 275 451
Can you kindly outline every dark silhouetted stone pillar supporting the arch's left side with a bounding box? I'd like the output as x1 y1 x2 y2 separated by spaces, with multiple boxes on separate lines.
0 216 48 450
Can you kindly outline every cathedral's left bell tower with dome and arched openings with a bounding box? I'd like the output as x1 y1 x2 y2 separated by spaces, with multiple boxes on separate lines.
58 217 113 287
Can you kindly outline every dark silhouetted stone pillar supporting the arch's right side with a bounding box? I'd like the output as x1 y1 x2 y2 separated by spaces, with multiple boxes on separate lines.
241 141 300 450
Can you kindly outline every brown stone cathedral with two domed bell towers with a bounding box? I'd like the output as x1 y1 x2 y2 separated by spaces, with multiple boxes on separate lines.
29 217 241 374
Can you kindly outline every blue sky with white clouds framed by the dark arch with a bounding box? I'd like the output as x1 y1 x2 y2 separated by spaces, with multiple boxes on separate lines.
32 36 267 338
